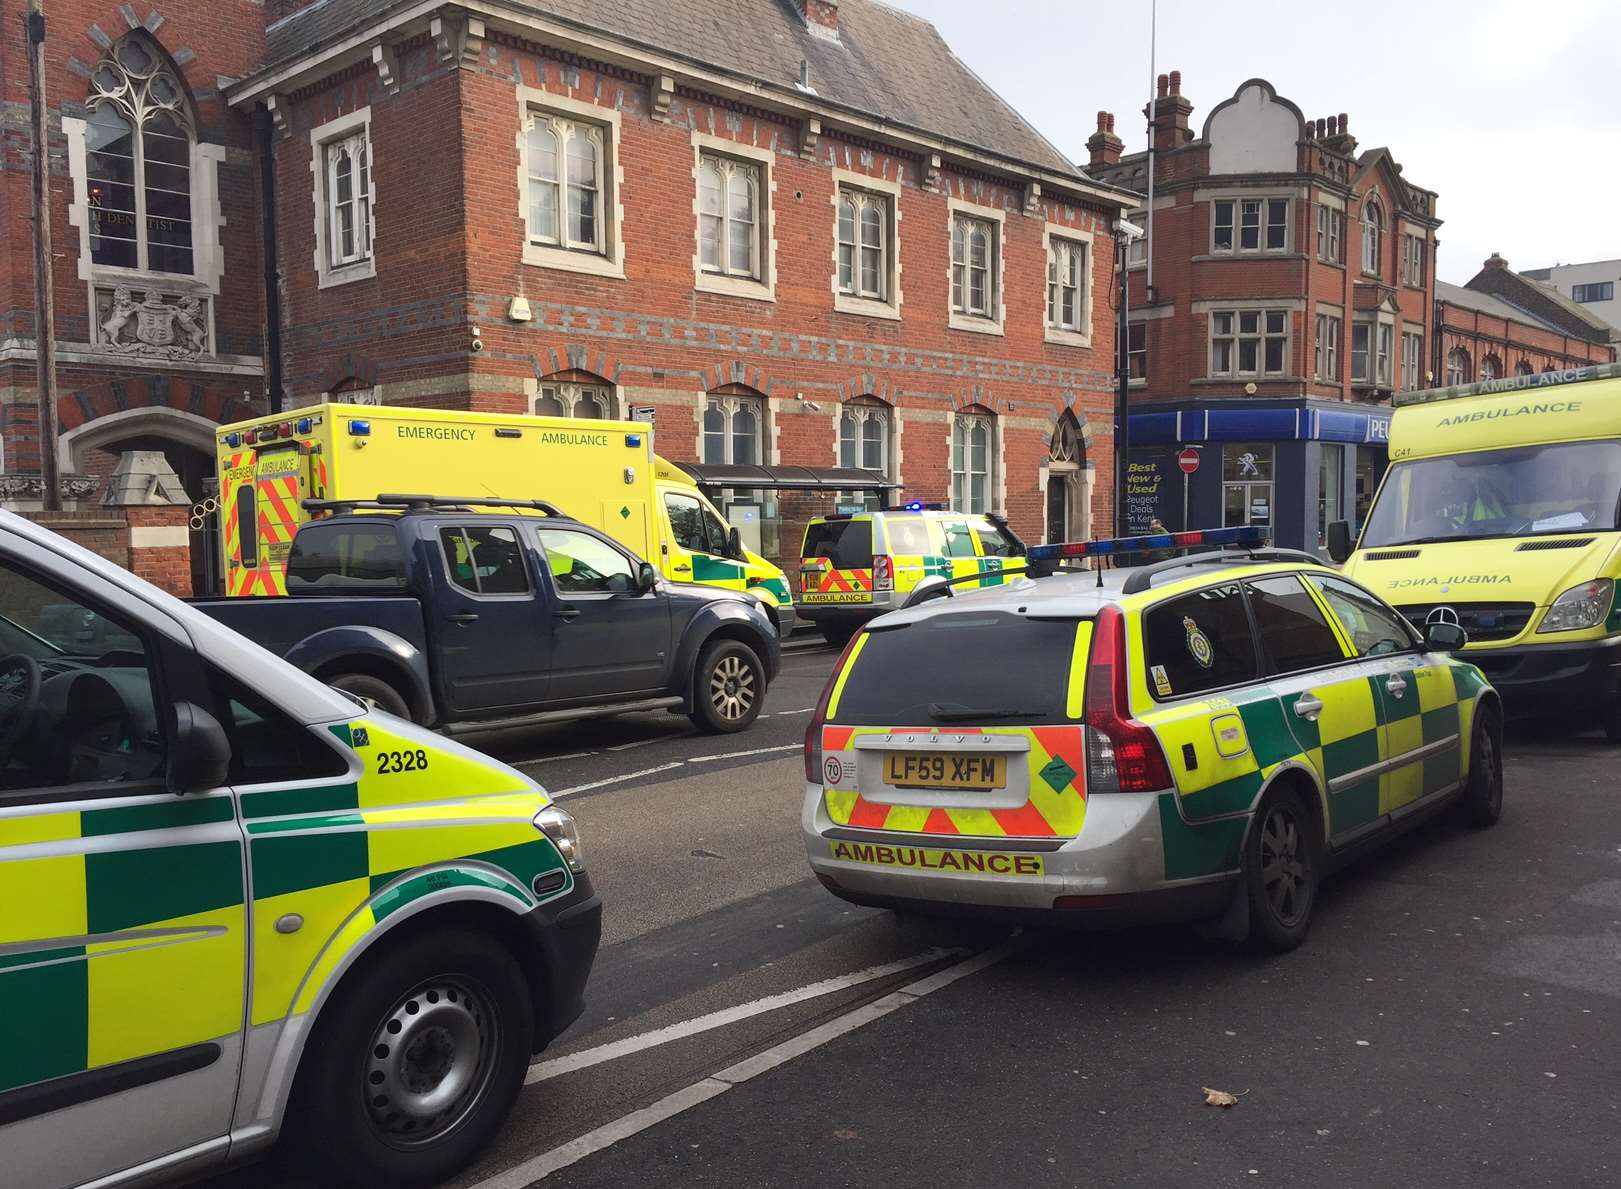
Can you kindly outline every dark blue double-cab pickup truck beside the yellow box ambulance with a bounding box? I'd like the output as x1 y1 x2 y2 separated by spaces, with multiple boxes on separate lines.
191 496 781 733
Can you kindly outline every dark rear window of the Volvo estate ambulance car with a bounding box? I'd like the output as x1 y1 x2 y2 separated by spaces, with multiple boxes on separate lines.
833 612 1078 728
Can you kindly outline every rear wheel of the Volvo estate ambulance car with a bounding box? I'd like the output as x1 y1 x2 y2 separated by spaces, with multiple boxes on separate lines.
1243 788 1321 951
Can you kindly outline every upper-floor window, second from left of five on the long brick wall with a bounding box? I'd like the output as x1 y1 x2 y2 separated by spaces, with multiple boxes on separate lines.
692 131 776 300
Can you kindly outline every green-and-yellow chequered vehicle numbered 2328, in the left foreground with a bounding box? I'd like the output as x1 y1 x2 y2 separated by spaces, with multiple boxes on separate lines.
0 511 601 1189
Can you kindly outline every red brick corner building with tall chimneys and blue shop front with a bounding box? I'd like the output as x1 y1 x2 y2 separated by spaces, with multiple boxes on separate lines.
1088 71 1439 548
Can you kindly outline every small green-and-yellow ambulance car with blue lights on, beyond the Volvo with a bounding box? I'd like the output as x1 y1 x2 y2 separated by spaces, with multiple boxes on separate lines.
794 501 1024 644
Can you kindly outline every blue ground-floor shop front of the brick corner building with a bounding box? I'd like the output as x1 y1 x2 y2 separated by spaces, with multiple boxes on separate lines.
1125 397 1391 556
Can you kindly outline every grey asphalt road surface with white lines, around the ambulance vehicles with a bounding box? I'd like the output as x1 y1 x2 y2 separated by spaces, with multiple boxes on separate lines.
211 647 1621 1189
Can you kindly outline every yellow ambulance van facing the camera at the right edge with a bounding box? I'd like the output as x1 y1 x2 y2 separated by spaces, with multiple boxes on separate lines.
1329 363 1621 743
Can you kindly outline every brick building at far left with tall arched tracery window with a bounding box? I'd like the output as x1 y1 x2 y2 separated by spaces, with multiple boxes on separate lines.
0 0 264 587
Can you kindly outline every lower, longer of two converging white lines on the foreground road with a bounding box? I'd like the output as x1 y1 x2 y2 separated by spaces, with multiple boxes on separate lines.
472 942 1018 1189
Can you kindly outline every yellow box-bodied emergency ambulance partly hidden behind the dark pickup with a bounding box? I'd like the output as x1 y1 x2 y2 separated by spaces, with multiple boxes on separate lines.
216 404 793 625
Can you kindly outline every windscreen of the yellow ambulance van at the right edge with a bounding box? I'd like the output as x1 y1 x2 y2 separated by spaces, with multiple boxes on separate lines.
1362 441 1621 548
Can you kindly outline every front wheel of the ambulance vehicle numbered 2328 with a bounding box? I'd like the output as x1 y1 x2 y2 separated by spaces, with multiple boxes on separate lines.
287 929 535 1189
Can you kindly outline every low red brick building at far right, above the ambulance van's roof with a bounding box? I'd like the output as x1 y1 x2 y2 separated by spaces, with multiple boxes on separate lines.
1435 253 1616 384
